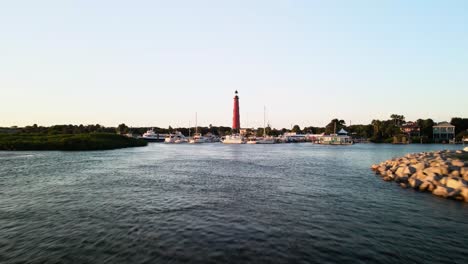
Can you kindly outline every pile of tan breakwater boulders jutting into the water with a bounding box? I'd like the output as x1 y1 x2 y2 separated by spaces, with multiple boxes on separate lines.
371 150 468 202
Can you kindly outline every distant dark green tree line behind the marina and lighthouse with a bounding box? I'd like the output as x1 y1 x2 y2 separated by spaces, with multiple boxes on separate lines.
0 114 468 143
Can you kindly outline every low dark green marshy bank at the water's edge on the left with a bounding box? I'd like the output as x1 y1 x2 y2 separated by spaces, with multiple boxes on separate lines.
0 133 147 150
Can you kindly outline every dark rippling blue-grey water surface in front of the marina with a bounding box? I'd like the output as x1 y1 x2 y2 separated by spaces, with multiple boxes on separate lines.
0 144 468 263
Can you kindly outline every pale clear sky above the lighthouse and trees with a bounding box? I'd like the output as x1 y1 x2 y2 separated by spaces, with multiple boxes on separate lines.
0 0 468 128
